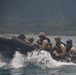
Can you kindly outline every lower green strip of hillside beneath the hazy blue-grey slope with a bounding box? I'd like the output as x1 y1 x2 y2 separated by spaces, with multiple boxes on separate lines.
0 20 76 35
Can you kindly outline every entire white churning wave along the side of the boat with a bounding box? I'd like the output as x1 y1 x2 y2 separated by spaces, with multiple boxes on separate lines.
0 50 75 68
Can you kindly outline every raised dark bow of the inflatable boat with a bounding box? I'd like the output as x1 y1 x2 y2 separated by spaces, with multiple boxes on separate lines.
0 34 34 59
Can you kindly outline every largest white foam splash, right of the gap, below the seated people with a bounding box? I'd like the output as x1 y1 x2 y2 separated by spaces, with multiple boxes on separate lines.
24 50 73 68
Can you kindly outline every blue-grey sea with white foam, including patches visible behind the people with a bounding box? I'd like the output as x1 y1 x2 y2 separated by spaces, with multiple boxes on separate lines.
0 34 76 75
